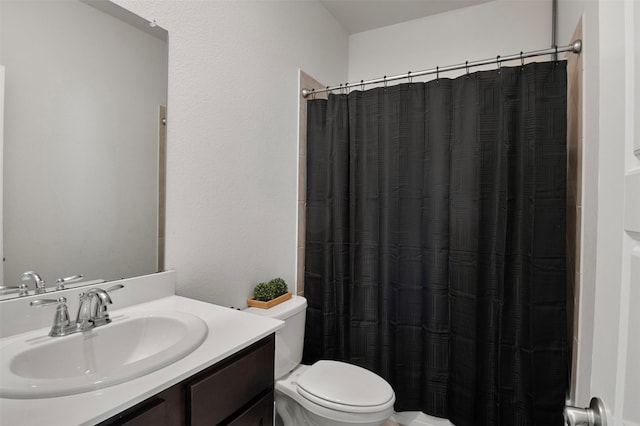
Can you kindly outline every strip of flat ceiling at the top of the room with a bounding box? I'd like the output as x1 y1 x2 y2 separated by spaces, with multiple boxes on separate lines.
320 0 491 34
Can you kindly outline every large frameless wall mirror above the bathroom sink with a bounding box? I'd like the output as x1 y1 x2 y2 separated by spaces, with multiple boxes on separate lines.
0 0 167 298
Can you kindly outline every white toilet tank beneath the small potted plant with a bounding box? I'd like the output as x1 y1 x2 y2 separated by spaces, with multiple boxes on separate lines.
244 296 307 380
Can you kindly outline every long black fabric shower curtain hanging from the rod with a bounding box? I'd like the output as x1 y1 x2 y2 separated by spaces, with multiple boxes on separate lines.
305 62 568 426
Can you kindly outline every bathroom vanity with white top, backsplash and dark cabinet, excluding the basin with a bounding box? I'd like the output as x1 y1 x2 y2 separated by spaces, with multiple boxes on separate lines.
0 272 282 426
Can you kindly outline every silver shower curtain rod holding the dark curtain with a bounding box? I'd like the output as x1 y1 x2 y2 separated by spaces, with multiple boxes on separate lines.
302 40 582 98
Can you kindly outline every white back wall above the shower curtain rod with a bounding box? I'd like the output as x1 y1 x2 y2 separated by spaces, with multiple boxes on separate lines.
348 0 552 84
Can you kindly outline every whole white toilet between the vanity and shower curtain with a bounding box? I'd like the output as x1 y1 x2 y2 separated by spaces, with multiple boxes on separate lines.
245 296 396 426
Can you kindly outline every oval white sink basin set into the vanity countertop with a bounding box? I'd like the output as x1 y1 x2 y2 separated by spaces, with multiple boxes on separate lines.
0 312 208 398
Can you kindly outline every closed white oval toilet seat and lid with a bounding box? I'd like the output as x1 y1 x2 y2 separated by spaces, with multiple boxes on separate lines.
297 360 395 413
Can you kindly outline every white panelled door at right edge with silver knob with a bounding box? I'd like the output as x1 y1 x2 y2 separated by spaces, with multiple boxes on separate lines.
592 0 640 426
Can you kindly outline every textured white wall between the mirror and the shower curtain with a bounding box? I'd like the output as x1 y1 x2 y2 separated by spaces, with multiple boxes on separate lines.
112 0 348 306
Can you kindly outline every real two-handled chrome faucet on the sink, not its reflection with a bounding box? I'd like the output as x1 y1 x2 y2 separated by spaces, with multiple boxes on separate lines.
31 284 124 337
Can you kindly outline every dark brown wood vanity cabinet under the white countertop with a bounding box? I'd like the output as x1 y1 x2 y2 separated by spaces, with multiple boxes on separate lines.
99 334 275 426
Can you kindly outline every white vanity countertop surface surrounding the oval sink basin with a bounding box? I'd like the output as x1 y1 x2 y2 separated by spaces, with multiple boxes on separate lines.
0 296 283 426
